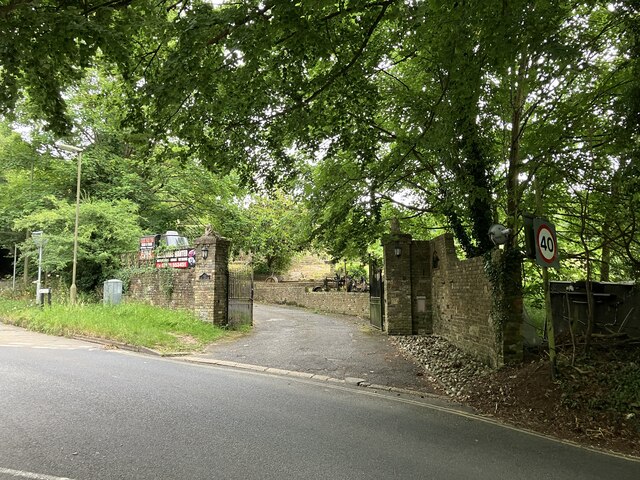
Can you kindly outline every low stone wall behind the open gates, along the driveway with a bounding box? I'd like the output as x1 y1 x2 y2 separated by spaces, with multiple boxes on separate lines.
254 282 369 318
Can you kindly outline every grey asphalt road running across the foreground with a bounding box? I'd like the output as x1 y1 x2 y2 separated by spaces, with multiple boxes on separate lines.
0 331 640 480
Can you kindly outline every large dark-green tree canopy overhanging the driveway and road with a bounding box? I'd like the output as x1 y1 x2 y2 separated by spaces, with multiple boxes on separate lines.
0 0 638 269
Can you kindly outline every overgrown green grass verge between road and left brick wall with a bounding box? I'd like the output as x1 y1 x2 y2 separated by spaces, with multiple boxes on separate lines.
0 298 242 353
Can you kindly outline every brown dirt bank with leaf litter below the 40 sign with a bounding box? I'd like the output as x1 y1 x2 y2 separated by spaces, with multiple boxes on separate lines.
444 340 640 457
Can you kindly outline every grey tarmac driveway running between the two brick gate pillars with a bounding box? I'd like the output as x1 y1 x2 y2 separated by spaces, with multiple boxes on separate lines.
192 304 433 393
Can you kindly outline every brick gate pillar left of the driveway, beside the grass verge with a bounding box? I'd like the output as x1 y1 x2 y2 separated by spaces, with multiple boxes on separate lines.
193 231 230 325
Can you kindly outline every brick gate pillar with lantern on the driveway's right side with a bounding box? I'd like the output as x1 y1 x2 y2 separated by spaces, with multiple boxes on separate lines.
382 233 413 335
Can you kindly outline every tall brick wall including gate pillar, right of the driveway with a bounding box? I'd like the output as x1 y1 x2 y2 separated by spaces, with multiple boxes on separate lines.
382 233 522 366
